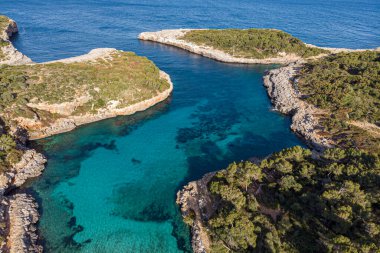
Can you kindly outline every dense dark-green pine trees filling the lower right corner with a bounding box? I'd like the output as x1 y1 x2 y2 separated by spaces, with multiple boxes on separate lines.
206 147 380 252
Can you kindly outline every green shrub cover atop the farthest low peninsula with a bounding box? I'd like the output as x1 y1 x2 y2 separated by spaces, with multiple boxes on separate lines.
180 29 325 59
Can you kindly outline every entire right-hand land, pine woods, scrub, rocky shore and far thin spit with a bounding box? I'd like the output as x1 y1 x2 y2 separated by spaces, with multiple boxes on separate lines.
139 29 380 253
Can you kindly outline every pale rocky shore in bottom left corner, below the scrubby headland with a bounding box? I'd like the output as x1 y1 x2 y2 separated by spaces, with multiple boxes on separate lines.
0 132 46 253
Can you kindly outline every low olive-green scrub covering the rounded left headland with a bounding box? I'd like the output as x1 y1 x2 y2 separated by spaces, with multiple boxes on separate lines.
0 52 169 126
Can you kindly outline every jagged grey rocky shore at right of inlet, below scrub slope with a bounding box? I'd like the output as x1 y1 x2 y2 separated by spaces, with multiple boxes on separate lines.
264 62 333 150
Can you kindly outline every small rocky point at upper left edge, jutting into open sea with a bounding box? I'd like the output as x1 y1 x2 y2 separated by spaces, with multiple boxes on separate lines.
0 16 32 65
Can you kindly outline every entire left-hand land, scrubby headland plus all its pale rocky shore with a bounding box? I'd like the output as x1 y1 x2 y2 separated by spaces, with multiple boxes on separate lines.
0 16 173 253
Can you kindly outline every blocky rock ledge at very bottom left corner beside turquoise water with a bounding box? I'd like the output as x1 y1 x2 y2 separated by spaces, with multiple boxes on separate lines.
2 193 42 253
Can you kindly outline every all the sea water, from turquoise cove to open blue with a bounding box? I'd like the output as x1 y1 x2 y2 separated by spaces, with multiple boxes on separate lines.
0 0 380 252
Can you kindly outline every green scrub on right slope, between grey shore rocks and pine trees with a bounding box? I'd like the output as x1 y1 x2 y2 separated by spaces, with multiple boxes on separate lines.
297 51 380 152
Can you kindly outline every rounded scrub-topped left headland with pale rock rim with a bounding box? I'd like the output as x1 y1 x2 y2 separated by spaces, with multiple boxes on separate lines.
0 49 173 139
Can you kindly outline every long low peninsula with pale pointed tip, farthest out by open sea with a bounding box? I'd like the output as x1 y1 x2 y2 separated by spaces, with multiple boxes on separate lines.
138 29 374 64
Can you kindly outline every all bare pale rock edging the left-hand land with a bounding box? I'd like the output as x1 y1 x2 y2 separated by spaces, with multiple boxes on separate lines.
0 16 173 253
